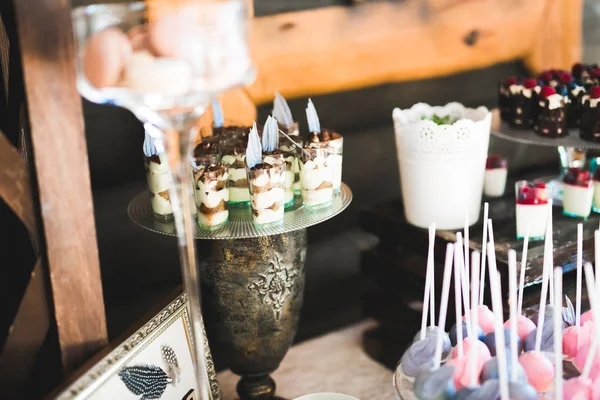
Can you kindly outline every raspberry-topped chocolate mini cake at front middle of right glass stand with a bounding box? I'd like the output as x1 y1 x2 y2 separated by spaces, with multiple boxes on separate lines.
533 86 569 138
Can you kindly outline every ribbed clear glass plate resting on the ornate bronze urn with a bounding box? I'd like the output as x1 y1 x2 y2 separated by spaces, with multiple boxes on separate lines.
127 183 352 240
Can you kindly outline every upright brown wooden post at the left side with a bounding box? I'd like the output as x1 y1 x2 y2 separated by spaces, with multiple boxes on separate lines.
14 0 107 372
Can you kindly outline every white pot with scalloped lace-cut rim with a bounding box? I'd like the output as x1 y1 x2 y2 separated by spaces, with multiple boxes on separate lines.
393 103 492 229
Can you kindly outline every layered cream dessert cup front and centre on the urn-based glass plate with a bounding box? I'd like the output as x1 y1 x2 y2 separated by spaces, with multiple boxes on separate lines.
246 159 285 225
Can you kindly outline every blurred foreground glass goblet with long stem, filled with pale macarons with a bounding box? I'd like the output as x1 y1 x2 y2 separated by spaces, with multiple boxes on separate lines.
72 0 254 399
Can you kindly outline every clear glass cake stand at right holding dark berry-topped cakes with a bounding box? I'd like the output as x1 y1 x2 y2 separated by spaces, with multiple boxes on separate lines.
491 110 600 205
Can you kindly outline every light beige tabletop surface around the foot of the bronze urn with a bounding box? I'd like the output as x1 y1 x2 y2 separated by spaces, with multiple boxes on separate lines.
219 320 396 400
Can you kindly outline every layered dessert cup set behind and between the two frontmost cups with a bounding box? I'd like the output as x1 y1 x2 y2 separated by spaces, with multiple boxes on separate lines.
221 143 250 206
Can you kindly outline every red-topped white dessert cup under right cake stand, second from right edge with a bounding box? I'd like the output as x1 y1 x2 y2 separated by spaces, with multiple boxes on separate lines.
563 168 594 219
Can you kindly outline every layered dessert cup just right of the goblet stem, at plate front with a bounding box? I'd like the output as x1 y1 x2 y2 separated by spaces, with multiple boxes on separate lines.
194 164 229 229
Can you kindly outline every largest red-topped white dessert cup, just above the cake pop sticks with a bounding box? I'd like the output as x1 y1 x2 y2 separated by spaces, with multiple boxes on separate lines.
515 181 551 240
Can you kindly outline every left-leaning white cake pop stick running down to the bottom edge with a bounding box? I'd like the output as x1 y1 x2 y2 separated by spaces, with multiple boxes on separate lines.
488 250 509 400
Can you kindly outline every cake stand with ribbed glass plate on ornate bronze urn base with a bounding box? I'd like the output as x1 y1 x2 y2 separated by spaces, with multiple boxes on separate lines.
127 184 352 400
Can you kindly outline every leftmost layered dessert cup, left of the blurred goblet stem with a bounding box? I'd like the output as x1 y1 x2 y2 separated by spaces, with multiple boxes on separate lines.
144 153 173 221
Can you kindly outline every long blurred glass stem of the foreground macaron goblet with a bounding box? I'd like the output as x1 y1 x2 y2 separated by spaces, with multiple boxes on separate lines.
165 129 212 400
